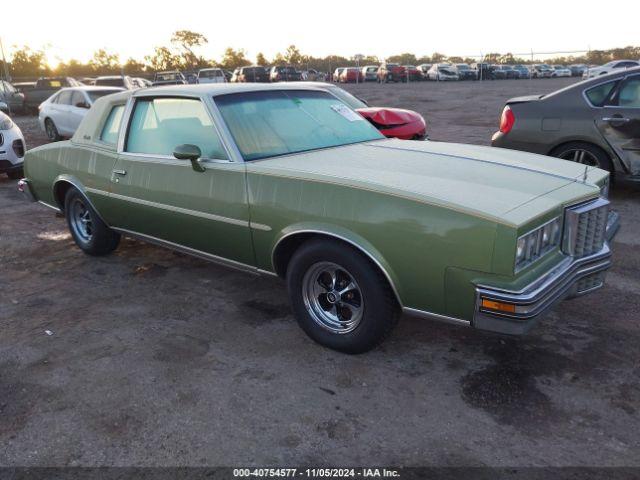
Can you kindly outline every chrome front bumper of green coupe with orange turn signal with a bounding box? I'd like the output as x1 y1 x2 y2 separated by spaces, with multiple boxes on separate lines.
473 212 620 335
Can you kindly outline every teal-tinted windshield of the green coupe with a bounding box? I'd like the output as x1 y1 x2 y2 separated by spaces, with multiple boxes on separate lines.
215 90 384 160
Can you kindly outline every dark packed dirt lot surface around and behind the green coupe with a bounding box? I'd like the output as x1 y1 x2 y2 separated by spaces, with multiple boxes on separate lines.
0 80 640 466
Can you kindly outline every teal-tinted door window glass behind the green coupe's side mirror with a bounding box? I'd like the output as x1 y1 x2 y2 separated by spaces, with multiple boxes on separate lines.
125 98 227 159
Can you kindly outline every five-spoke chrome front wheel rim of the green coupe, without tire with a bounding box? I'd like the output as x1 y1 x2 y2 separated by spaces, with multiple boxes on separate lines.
302 262 364 334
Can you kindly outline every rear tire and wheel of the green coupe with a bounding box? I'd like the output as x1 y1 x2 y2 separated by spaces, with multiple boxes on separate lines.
64 187 120 256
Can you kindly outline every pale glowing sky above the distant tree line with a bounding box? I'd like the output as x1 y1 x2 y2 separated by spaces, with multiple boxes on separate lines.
0 0 640 66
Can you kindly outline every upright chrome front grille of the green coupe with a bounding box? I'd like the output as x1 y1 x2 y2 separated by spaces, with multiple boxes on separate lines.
562 198 609 257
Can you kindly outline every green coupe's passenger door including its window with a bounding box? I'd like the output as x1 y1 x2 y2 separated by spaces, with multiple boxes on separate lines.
112 96 255 266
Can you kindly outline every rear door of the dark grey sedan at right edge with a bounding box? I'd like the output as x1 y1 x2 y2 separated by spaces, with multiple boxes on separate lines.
596 75 640 175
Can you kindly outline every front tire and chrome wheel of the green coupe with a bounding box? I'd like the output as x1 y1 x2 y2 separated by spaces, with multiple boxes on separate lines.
287 240 400 354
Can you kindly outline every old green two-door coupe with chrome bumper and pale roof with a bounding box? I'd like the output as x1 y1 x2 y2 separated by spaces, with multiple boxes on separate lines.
19 83 618 353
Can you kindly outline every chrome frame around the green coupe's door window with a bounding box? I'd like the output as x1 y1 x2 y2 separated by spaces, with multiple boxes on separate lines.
117 93 234 165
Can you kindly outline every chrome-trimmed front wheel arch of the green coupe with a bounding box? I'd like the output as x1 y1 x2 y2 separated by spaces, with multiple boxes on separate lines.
271 226 403 308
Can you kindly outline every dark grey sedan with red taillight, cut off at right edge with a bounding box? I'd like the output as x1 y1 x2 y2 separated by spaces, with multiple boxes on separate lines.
492 68 640 181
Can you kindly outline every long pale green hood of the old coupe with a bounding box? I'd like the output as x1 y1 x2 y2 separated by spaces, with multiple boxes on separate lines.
247 139 604 225
